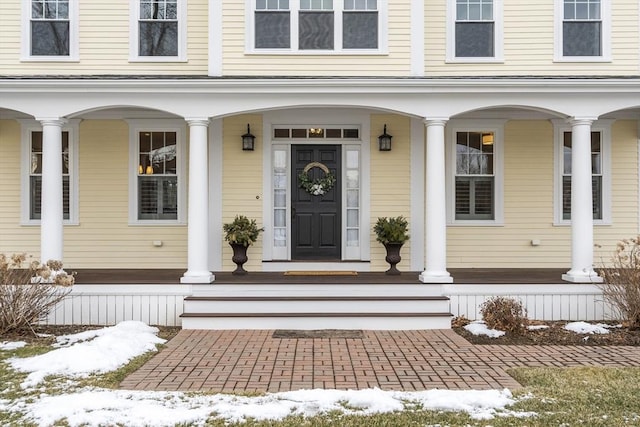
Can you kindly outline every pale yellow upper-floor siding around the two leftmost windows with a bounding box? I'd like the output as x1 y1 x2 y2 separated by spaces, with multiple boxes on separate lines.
0 0 208 75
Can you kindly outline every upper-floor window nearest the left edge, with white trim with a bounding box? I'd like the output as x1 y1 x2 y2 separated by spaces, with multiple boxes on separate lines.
22 0 78 61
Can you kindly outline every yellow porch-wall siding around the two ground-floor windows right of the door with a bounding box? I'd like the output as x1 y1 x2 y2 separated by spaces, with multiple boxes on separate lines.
447 121 638 268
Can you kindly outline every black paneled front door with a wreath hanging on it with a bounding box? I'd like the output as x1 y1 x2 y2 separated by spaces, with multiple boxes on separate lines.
291 145 342 261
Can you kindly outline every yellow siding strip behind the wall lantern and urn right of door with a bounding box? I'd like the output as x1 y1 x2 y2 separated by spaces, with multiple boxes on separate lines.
363 114 411 271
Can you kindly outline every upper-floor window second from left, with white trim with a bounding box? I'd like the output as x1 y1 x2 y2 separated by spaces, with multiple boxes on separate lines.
131 0 186 61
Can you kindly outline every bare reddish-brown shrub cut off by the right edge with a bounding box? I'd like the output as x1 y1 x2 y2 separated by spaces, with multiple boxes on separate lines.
598 236 640 329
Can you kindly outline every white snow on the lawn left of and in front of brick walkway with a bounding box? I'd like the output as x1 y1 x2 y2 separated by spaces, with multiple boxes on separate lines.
0 322 535 426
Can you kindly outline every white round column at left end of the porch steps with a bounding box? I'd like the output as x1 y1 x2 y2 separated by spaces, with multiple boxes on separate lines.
180 118 215 283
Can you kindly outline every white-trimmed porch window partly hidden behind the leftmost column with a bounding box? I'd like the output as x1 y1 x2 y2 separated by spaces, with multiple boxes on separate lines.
21 121 78 224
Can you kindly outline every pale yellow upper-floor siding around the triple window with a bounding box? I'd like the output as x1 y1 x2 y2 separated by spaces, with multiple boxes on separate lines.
223 0 411 76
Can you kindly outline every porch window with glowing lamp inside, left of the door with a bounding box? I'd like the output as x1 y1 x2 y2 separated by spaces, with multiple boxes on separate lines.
130 120 186 224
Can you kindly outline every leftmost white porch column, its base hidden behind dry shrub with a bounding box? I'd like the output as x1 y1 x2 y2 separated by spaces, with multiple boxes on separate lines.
38 118 65 263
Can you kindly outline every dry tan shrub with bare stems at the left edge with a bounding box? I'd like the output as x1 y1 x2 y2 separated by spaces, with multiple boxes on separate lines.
0 254 75 335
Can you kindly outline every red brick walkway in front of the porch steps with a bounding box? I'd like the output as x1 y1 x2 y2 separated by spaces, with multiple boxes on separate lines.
121 330 640 392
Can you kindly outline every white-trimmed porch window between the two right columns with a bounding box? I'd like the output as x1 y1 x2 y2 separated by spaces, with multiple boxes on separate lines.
447 120 504 225
